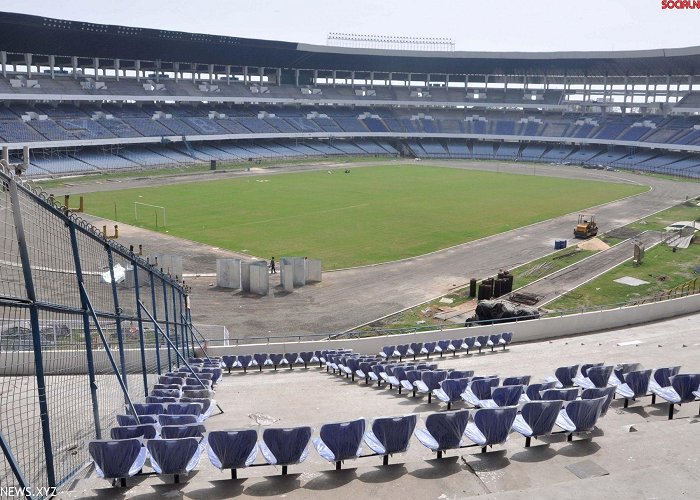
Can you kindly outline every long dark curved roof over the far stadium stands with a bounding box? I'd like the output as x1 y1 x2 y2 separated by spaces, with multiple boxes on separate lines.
0 12 700 76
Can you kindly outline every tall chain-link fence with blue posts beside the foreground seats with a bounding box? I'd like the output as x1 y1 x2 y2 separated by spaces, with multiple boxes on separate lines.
0 165 199 491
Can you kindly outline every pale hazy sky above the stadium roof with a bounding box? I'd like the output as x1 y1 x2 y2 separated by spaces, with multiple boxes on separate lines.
5 0 700 52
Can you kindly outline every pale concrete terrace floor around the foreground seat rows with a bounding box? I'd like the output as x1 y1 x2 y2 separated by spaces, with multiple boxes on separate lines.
63 314 700 500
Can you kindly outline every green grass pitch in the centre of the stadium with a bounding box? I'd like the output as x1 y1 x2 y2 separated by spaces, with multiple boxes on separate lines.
80 165 647 269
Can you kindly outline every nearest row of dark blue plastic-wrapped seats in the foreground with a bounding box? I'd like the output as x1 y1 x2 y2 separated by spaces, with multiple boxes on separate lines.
89 398 605 485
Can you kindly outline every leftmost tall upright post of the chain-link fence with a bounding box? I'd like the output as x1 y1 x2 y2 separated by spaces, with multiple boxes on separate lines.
8 177 56 486
